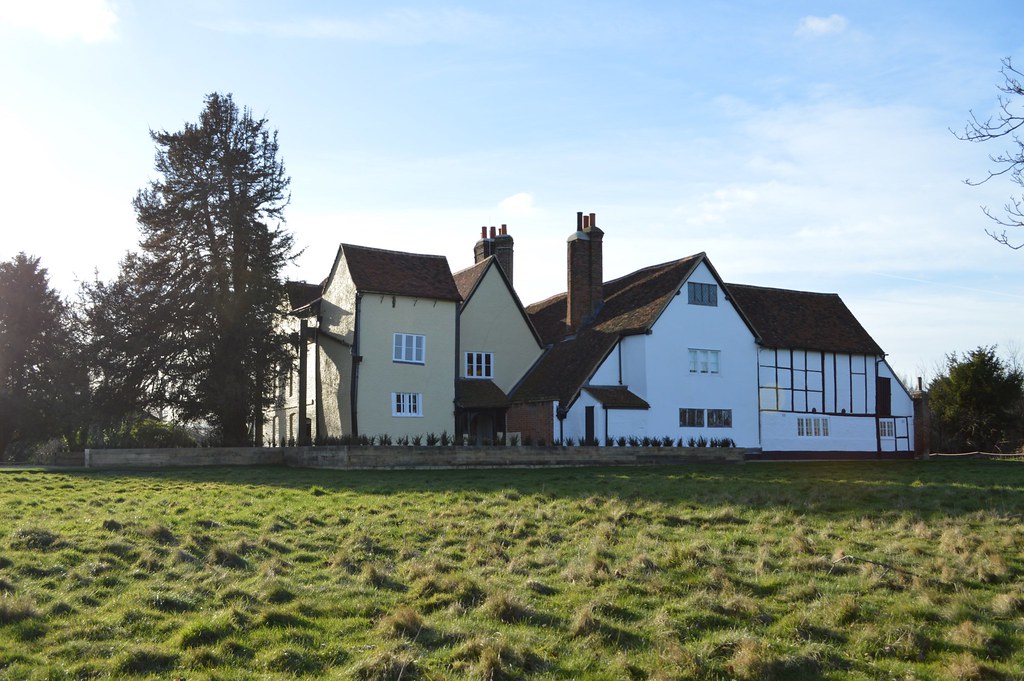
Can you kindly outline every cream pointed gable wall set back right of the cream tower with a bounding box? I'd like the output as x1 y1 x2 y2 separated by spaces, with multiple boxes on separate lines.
459 267 541 393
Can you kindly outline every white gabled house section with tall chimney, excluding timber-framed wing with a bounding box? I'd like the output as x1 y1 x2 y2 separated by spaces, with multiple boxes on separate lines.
513 213 760 448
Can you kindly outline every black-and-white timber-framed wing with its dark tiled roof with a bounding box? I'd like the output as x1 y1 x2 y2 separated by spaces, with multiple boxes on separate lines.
729 284 914 452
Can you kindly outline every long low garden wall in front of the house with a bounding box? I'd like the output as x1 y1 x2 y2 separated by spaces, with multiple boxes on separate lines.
85 445 760 470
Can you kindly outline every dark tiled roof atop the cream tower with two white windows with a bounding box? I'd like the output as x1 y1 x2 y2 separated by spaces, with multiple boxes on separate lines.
341 244 462 301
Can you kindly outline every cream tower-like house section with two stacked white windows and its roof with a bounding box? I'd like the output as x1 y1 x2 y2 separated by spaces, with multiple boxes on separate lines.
315 244 461 438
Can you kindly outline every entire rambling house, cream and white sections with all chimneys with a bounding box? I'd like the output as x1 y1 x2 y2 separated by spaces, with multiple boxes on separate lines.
265 213 920 456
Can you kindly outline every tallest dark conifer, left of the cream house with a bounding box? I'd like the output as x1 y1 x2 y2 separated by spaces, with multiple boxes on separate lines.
85 93 294 444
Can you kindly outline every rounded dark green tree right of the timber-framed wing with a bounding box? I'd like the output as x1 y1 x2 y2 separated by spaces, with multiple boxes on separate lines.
928 347 1024 452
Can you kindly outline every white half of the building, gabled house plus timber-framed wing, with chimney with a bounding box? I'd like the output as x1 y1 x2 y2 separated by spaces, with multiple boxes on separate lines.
510 213 914 453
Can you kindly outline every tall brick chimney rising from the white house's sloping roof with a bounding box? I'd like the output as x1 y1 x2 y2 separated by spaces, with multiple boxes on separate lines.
565 213 604 333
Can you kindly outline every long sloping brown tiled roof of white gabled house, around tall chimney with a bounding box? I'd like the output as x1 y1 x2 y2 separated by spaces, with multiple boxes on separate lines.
512 253 705 405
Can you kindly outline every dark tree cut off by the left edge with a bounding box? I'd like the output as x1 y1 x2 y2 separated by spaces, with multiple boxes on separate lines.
0 253 87 455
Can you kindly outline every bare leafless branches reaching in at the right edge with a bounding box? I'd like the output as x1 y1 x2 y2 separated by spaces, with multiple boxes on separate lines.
954 57 1024 250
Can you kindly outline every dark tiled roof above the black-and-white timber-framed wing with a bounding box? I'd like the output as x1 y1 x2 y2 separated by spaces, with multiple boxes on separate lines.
726 284 884 354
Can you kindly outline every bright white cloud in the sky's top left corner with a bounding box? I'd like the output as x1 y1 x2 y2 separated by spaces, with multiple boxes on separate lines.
0 0 118 43
